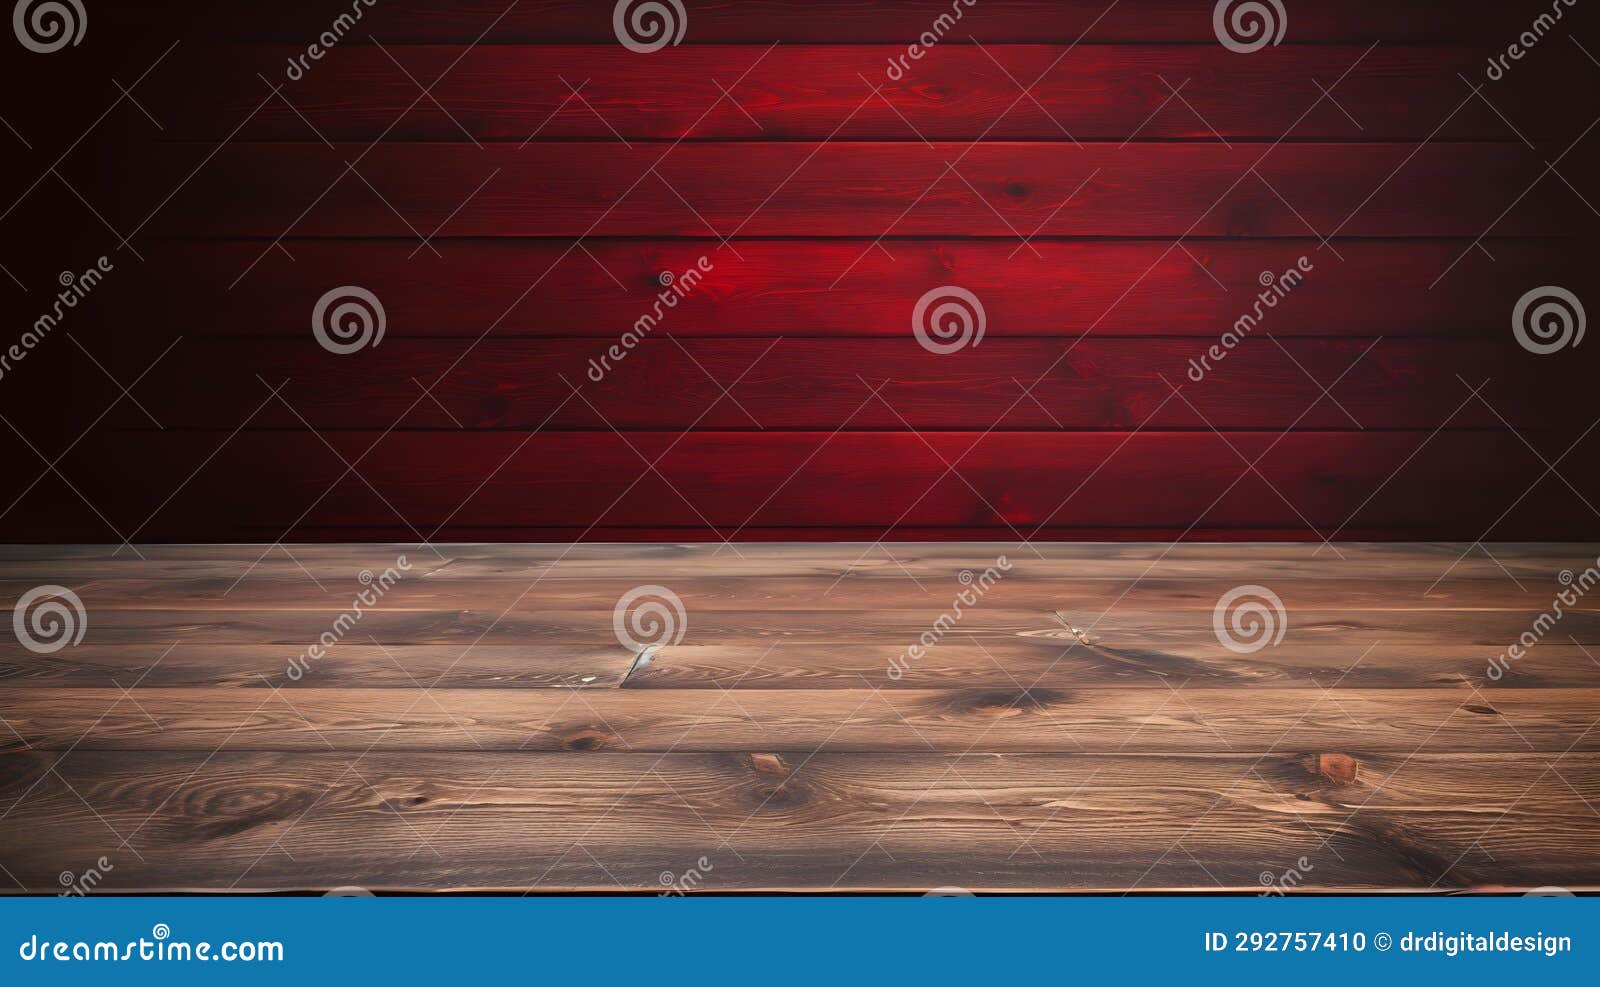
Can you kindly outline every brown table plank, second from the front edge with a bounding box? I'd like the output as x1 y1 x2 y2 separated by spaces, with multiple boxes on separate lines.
0 684 1600 745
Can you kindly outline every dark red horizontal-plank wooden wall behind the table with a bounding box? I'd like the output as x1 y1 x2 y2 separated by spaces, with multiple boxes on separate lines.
0 0 1600 542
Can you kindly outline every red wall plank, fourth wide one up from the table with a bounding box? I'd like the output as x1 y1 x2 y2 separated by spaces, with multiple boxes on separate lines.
123 139 1595 238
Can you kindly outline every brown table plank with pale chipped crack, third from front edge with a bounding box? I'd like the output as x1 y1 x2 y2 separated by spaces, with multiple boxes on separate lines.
0 638 1600 689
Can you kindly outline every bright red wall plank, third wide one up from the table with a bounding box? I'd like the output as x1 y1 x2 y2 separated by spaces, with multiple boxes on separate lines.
68 238 1589 339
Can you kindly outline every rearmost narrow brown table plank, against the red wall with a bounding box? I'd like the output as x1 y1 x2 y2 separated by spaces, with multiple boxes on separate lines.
0 541 1597 582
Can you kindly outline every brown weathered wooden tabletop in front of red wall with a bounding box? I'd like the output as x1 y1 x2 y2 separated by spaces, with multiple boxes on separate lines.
0 544 1600 893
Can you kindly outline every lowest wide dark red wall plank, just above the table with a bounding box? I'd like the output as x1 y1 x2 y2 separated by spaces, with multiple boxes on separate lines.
21 431 1600 541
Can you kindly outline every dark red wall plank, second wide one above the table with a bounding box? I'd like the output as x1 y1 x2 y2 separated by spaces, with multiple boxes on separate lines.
72 334 1600 430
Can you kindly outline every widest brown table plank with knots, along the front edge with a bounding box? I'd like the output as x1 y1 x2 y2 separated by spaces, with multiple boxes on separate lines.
0 750 1600 891
